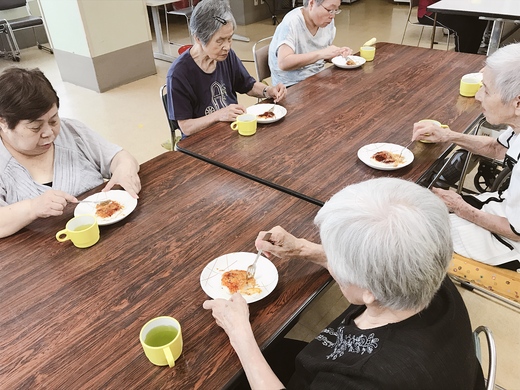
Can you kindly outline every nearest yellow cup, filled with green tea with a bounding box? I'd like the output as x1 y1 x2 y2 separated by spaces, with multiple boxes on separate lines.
139 316 182 367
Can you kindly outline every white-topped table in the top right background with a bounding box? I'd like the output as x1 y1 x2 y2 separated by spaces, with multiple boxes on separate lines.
428 0 520 55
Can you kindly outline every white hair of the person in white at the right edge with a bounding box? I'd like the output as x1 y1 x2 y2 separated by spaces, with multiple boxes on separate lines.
486 43 520 103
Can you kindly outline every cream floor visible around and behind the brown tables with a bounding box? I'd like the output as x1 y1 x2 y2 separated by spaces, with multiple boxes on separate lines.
0 0 520 390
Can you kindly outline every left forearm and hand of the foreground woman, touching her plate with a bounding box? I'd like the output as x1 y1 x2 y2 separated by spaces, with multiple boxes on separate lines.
203 293 284 390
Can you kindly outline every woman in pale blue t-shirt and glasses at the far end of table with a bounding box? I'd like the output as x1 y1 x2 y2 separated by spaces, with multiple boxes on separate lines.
269 0 352 87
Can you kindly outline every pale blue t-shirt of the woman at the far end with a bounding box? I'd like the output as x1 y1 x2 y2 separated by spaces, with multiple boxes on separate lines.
269 7 336 87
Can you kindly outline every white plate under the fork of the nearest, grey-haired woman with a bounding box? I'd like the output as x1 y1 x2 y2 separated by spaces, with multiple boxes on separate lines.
200 252 278 303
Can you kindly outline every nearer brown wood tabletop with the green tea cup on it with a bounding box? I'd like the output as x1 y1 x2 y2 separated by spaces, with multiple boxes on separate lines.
0 152 324 390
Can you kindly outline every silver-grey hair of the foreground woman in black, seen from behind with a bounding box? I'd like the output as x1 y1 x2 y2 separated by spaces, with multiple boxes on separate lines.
314 178 453 310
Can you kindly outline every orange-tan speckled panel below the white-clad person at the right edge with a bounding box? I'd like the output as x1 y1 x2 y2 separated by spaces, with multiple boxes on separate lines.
448 253 520 303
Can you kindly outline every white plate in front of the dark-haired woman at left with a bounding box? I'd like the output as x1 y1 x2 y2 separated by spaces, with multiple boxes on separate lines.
74 190 137 226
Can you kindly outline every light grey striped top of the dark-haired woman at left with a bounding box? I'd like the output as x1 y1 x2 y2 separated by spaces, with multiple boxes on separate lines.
0 118 122 206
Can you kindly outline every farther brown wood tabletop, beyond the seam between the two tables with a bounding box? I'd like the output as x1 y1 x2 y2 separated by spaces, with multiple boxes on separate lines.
178 43 485 205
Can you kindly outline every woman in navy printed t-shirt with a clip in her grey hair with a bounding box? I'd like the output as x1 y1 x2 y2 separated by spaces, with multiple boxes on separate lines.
166 0 286 135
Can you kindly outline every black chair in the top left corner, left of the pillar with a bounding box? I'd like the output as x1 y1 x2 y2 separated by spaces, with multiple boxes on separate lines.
0 0 53 61
